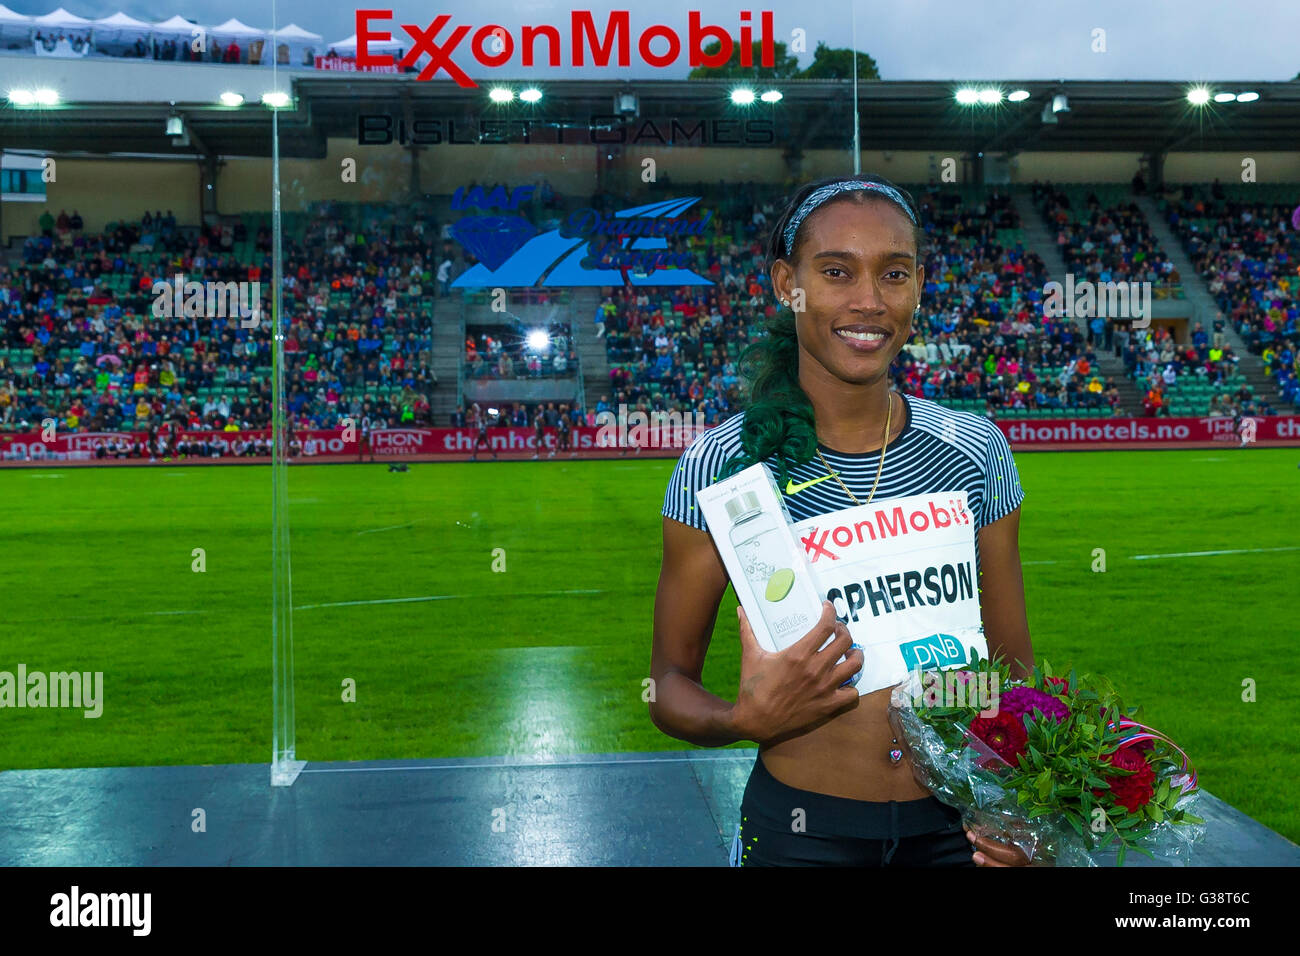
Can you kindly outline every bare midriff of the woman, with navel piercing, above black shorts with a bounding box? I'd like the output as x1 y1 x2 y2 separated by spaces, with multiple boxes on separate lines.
759 687 930 803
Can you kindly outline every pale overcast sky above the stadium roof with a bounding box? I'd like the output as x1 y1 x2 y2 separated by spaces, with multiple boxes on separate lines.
5 0 1300 81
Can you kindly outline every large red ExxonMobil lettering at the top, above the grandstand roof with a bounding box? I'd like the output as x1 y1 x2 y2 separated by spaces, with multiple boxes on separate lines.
356 9 776 87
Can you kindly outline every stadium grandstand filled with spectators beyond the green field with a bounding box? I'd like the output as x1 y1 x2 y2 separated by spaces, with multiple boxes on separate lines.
0 59 1300 458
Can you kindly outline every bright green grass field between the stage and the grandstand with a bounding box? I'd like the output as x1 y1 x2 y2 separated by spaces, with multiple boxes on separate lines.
0 447 1300 840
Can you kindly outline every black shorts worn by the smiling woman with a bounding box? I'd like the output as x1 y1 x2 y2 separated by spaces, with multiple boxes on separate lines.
731 757 975 866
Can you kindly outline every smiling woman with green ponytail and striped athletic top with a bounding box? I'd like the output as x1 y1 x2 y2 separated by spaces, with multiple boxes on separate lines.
650 177 1034 866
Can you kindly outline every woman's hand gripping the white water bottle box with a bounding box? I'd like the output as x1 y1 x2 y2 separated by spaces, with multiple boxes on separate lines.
732 601 862 744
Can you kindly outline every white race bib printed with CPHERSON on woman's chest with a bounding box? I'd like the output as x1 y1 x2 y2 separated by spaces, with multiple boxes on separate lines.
794 492 988 695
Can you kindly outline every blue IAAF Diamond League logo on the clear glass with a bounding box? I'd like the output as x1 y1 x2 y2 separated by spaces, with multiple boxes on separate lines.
451 196 714 289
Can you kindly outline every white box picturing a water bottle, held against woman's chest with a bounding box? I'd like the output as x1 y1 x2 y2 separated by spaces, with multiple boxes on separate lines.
696 463 833 652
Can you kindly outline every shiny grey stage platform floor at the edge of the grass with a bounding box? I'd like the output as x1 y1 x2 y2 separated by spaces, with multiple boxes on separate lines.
0 749 1300 866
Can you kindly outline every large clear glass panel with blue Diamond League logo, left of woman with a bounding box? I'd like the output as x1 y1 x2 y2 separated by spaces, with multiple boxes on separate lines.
280 10 853 775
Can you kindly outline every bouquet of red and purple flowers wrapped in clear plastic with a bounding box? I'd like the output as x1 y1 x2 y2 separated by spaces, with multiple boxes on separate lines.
889 656 1205 866
